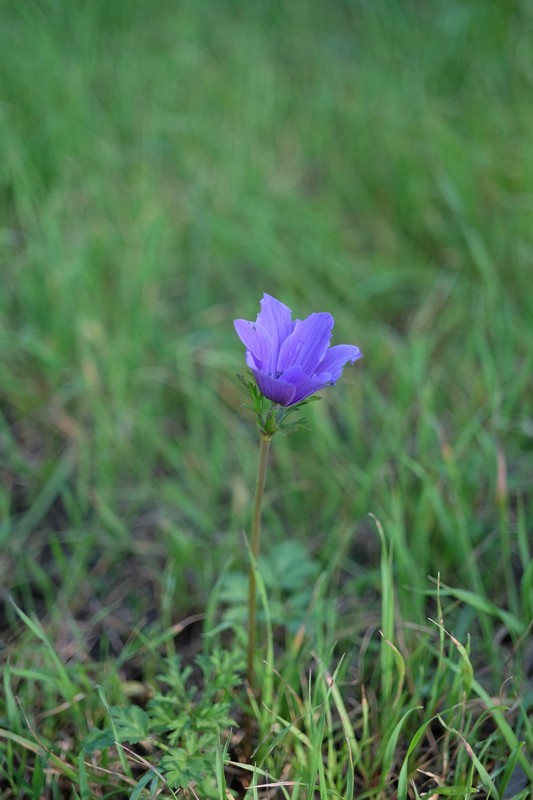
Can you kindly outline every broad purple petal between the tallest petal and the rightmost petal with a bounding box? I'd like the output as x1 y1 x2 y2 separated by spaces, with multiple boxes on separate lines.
277 313 334 375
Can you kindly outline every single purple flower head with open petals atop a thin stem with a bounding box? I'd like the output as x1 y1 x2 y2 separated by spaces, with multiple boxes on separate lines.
235 294 362 406
